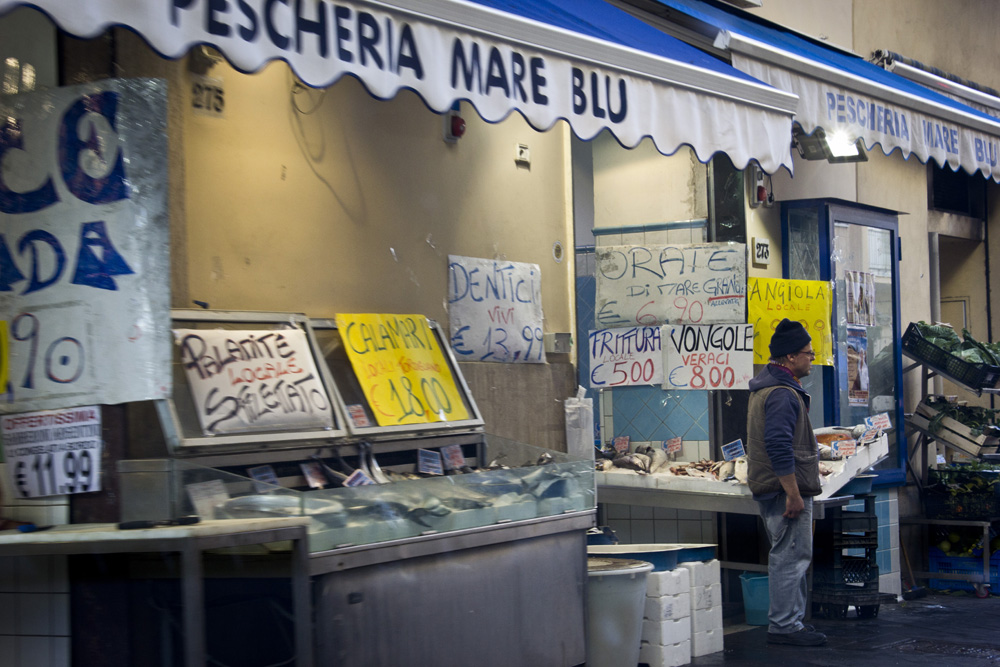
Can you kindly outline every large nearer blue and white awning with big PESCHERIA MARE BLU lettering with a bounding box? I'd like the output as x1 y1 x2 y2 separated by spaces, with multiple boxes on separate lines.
0 0 797 172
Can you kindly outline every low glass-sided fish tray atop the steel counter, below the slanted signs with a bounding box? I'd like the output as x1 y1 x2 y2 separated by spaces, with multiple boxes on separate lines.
121 435 596 552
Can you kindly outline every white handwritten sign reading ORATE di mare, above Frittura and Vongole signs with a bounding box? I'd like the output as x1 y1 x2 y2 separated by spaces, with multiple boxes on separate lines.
594 243 747 328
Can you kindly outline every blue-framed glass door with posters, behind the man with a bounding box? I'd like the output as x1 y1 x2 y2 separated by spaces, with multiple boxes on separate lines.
782 200 905 484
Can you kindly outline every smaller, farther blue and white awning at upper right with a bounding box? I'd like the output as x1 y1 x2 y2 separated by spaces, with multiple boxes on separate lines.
657 0 1000 182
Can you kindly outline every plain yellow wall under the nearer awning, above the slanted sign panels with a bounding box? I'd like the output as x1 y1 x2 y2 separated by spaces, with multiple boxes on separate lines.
173 64 572 332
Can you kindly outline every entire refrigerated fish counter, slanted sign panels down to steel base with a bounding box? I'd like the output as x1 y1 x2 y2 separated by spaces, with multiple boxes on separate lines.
118 310 596 666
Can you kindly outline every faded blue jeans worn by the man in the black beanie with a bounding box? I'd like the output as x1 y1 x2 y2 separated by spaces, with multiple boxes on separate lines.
757 492 813 634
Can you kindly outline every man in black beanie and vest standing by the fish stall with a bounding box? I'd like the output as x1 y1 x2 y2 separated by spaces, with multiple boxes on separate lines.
747 318 826 646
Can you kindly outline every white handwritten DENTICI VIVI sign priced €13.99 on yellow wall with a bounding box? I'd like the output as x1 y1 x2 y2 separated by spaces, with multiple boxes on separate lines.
448 255 545 364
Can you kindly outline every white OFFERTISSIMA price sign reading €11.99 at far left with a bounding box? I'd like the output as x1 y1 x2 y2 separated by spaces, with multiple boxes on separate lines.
0 406 104 498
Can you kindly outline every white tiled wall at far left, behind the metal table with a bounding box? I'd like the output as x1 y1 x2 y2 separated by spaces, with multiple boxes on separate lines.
0 463 70 667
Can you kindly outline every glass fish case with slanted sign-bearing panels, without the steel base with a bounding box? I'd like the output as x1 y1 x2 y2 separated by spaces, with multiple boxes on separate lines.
125 310 596 553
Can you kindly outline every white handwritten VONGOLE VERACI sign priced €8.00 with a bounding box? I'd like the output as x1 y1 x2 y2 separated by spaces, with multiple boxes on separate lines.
663 324 753 390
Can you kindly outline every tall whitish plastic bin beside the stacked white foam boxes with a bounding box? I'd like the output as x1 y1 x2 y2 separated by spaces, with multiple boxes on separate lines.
587 556 653 667
